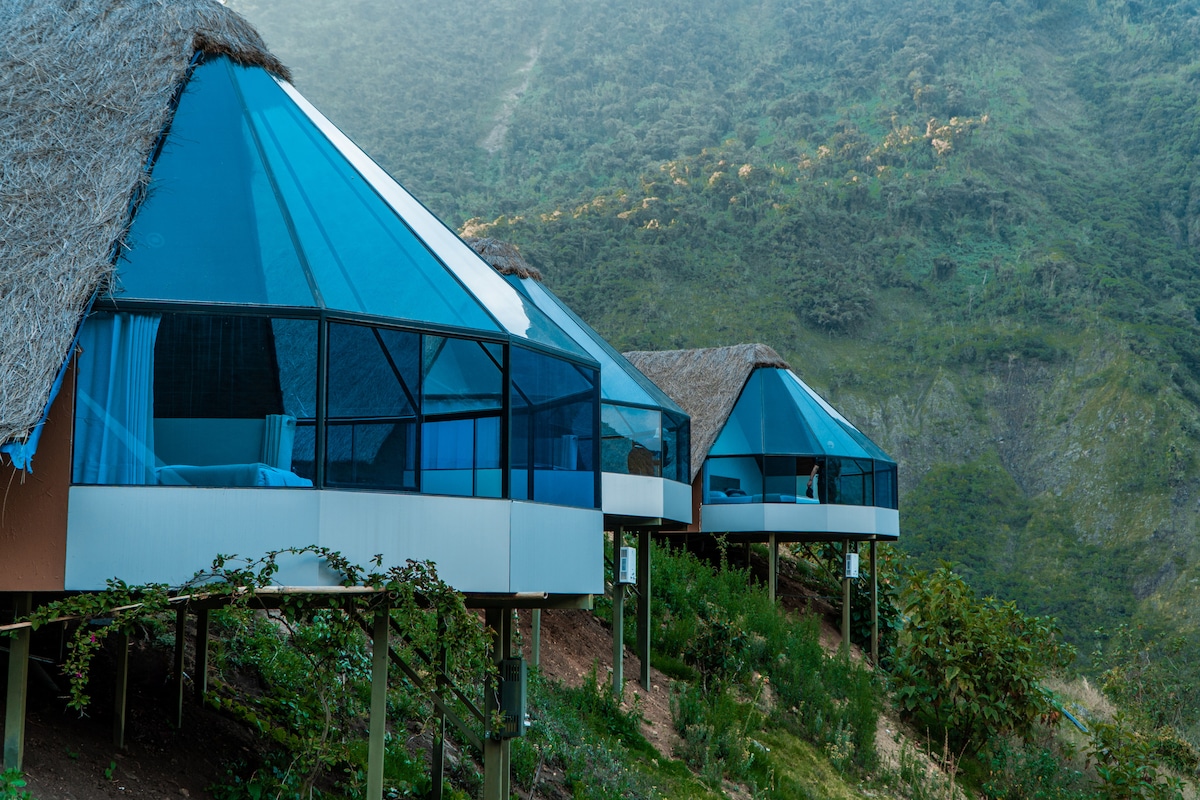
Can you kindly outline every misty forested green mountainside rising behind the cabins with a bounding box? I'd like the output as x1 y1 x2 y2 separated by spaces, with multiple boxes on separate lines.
230 0 1200 690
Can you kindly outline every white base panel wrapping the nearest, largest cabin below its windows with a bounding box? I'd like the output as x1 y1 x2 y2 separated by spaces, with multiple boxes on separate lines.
66 486 604 594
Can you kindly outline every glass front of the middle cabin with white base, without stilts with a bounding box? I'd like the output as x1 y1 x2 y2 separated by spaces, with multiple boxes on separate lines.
508 275 692 524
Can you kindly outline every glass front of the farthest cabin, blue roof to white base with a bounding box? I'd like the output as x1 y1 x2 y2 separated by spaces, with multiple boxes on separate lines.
701 367 900 539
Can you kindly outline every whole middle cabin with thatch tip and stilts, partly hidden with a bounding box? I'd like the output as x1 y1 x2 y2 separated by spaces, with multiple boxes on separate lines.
467 237 694 696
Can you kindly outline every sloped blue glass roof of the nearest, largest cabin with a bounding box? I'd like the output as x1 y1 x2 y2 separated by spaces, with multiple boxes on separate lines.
114 58 587 359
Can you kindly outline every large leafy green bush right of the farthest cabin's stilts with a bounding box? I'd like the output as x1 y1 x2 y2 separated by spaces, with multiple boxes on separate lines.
892 564 1074 754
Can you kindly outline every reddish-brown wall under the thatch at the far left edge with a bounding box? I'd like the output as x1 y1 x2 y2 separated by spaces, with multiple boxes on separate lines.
0 361 76 591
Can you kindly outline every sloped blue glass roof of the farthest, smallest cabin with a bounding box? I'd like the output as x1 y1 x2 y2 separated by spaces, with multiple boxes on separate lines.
709 367 895 463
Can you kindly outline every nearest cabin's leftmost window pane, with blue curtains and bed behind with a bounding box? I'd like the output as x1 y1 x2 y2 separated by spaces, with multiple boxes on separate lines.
73 313 316 487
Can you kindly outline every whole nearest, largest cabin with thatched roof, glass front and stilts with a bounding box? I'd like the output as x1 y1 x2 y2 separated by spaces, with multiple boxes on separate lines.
0 0 600 798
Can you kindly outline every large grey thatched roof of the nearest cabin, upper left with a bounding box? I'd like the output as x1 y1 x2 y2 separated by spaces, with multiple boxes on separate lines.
0 0 288 444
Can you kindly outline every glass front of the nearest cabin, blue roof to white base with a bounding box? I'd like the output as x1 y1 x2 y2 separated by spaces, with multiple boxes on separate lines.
67 56 604 594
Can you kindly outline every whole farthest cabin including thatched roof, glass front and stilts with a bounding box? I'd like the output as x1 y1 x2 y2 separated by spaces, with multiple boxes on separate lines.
625 344 900 660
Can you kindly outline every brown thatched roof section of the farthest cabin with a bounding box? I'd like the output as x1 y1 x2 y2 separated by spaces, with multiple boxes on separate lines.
624 344 788 480
